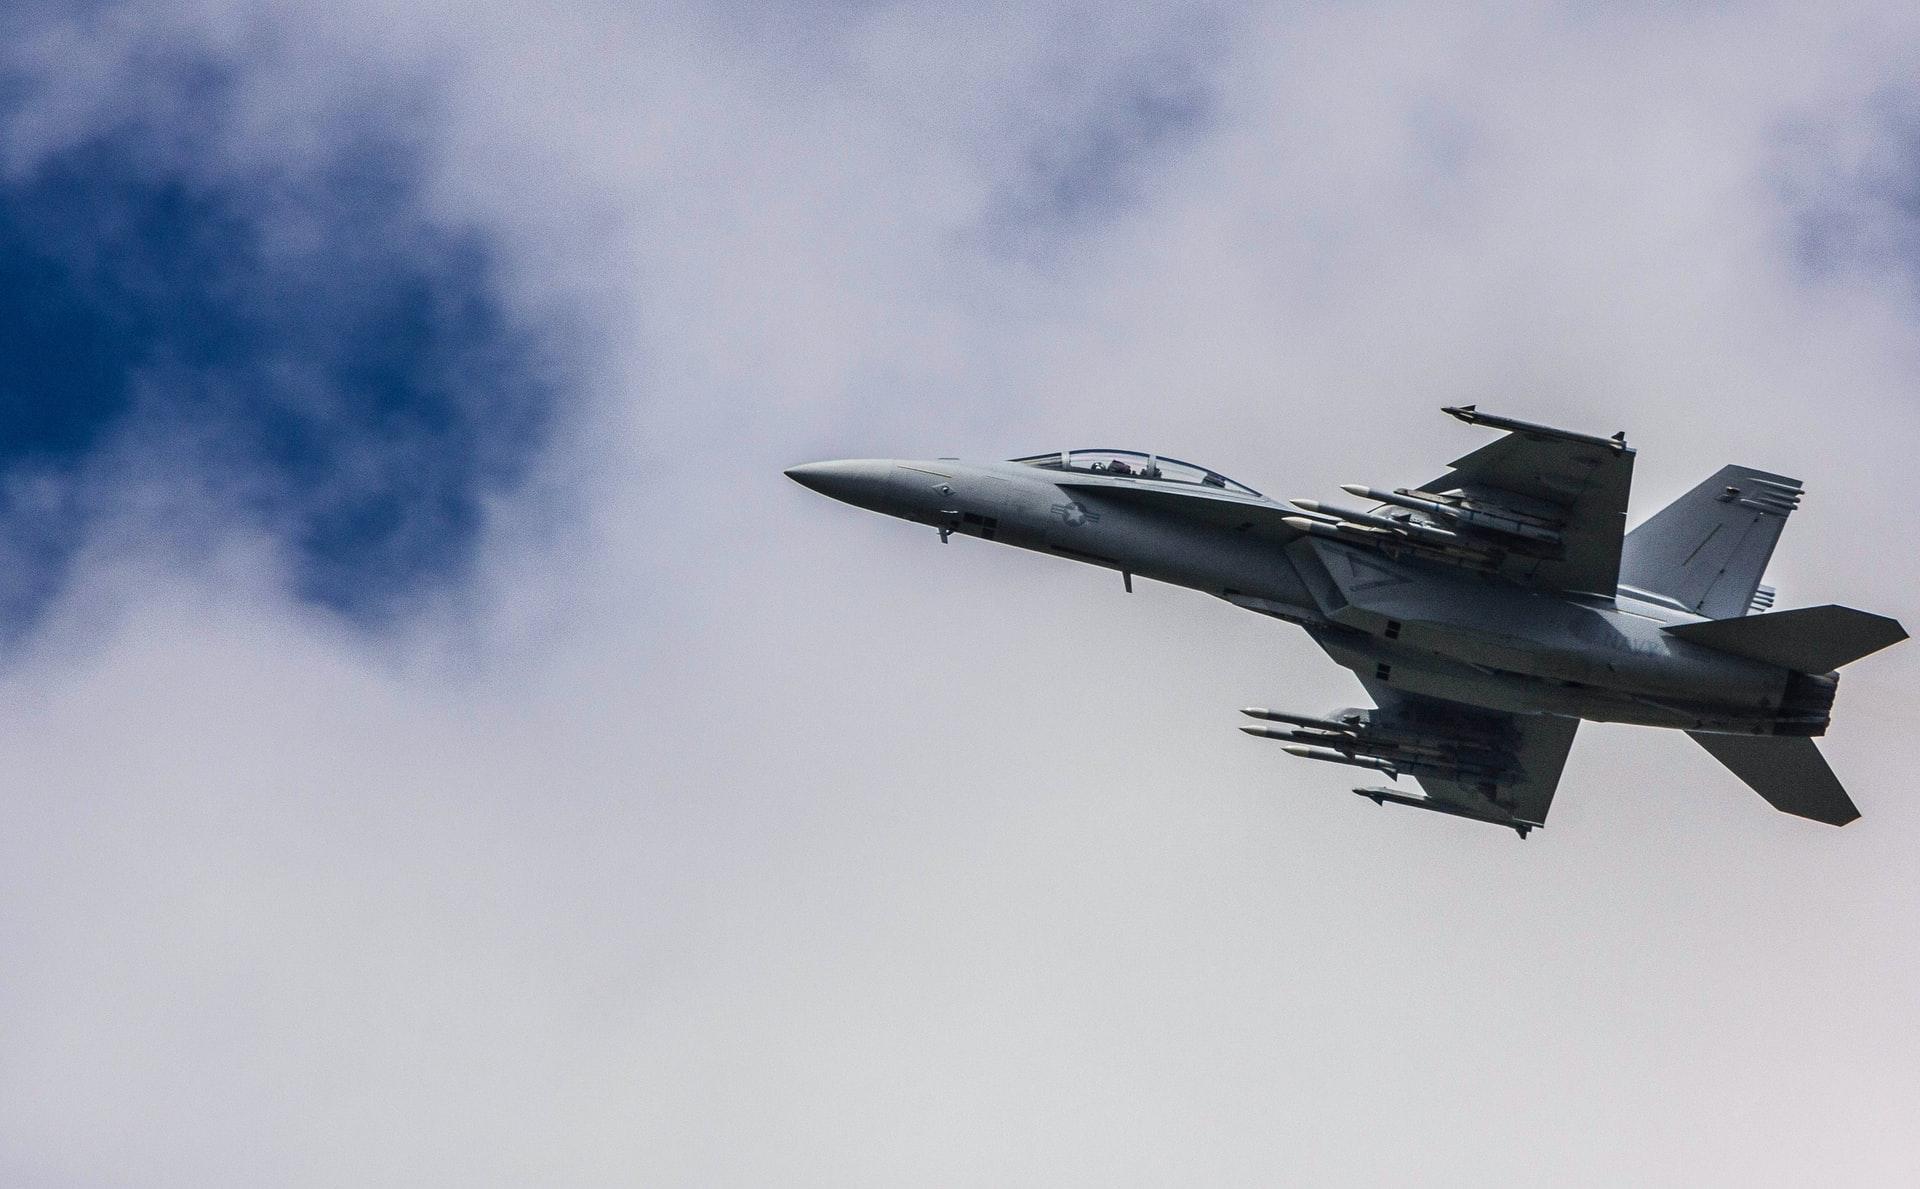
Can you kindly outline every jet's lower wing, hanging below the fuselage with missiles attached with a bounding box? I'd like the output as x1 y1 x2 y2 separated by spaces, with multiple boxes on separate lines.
1354 678 1580 837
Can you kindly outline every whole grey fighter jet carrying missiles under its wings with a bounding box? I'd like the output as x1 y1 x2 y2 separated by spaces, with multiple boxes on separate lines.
787 405 1907 837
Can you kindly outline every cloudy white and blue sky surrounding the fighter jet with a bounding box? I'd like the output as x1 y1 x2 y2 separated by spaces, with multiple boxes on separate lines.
0 0 1920 1187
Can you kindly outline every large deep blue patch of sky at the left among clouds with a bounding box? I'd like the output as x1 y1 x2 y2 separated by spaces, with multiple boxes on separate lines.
0 48 564 632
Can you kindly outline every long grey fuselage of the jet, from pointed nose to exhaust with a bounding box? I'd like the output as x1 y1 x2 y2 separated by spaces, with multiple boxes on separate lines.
789 459 1836 734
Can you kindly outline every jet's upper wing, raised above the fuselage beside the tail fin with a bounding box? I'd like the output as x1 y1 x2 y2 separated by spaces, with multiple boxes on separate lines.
1405 405 1634 597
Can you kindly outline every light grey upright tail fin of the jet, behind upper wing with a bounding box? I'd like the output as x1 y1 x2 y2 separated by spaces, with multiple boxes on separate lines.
1620 467 1801 619
